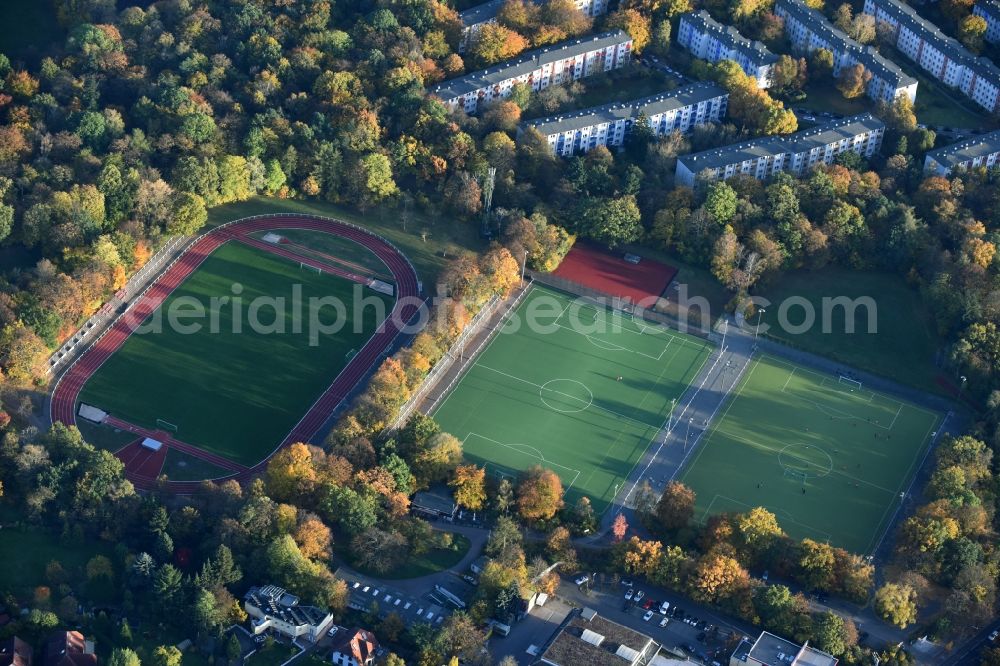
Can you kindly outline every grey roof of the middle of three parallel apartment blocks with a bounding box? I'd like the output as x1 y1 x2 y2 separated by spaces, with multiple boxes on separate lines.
525 82 729 136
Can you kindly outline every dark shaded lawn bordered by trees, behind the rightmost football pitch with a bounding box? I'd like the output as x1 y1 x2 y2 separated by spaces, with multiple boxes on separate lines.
751 268 940 391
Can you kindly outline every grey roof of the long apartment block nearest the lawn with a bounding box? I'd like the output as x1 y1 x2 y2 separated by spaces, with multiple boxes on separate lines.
678 113 885 173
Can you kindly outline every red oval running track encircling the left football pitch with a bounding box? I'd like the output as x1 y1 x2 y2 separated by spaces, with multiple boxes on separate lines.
49 215 421 494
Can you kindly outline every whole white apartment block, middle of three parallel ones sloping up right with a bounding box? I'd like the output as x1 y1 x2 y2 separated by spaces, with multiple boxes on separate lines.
522 82 729 157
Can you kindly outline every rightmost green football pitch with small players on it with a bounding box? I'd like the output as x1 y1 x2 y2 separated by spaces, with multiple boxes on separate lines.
680 356 941 554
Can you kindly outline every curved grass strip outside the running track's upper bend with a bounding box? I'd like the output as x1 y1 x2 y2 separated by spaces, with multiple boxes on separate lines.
208 197 485 284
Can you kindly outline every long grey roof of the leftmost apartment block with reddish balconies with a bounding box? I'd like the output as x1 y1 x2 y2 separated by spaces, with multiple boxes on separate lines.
431 30 632 99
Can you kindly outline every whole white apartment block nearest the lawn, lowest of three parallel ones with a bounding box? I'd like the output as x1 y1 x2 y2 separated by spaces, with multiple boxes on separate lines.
674 113 885 187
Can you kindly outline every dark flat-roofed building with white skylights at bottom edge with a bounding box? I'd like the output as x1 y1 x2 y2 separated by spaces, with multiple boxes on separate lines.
537 608 660 666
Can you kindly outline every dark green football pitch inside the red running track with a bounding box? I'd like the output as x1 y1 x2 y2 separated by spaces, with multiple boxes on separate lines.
80 242 393 466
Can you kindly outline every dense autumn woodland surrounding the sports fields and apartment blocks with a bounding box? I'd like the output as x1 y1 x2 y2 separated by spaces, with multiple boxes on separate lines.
0 0 1000 666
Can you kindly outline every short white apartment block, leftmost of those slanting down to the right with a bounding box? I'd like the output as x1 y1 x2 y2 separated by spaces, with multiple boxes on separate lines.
677 9 778 88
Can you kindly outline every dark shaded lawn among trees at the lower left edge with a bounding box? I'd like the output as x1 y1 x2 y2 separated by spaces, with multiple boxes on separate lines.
0 526 114 603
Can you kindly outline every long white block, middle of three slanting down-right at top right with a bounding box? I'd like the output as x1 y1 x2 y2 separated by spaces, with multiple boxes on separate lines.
774 0 917 102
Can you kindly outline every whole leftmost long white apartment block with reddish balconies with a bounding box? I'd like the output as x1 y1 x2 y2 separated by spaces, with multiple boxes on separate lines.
430 30 632 113
